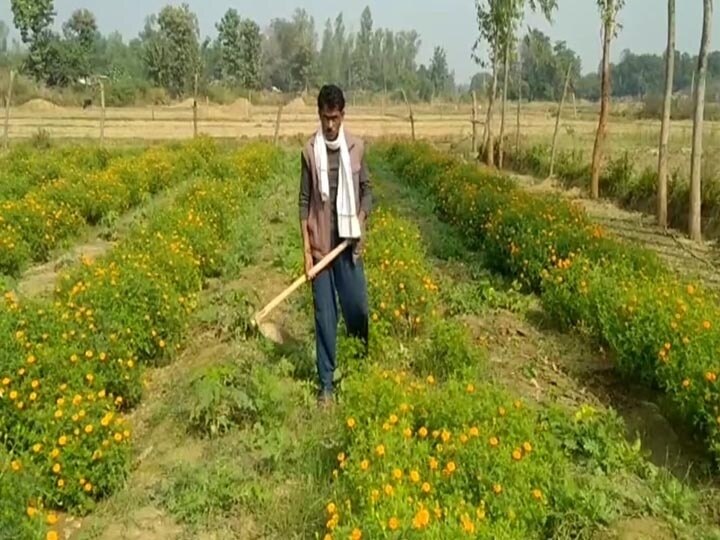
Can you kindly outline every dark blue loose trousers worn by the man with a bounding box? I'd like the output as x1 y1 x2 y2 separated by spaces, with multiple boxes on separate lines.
312 249 369 395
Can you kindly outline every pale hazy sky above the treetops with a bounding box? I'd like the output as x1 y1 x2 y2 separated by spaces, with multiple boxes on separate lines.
0 0 720 83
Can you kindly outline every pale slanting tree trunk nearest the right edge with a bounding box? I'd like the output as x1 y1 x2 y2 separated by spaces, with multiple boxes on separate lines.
689 0 713 242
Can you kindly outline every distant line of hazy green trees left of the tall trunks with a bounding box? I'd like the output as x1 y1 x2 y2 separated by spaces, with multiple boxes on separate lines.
0 0 456 100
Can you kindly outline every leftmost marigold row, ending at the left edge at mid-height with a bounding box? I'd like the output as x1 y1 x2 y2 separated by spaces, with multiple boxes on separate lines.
0 140 217 276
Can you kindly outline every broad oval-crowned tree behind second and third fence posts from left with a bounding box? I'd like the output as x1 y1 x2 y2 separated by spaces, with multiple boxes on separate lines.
141 4 201 97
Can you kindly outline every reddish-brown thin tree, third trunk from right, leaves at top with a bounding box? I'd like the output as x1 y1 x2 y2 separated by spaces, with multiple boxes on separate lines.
590 0 625 199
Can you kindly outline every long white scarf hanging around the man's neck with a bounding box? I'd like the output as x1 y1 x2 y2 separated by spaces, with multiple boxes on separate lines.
315 126 361 238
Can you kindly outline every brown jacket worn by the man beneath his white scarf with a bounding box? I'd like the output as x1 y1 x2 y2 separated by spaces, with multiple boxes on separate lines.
300 131 372 259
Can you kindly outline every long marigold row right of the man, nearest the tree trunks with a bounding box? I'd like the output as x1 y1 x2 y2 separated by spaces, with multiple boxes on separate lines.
376 143 720 466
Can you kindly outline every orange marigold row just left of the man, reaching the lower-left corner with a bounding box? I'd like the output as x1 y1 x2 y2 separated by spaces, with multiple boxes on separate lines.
0 142 276 538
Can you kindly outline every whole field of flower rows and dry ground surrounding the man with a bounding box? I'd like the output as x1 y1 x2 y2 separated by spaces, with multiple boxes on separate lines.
0 99 720 540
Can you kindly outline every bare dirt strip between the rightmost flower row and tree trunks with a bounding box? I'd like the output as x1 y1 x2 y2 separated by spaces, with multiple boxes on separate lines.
512 174 720 288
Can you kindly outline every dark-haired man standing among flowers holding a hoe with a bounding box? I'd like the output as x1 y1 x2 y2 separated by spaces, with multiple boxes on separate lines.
299 85 372 405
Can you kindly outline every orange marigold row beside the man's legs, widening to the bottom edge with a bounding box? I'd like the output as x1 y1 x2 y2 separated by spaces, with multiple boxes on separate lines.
321 211 696 540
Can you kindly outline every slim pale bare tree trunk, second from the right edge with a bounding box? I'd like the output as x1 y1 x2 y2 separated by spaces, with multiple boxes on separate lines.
657 0 675 229
